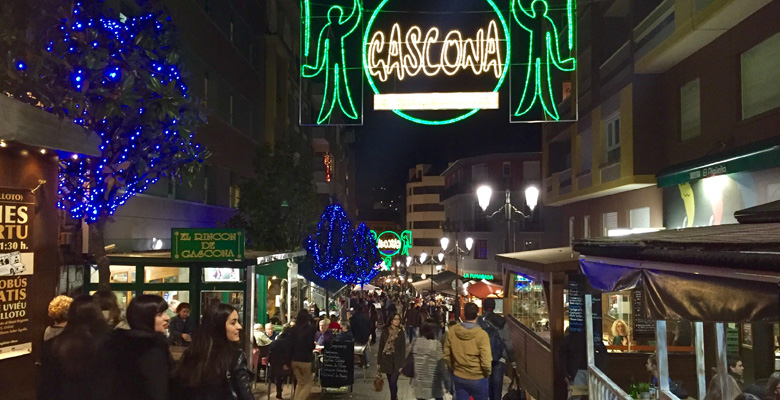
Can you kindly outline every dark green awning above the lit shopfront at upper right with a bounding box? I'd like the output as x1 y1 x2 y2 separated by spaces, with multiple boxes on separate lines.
656 137 780 187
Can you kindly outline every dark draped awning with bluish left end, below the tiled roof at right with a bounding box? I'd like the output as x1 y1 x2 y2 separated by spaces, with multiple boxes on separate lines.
580 260 780 322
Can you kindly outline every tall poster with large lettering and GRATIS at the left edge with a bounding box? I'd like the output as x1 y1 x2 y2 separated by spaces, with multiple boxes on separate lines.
0 188 35 360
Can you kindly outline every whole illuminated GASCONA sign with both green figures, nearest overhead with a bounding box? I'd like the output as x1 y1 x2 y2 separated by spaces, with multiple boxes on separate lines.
300 0 577 125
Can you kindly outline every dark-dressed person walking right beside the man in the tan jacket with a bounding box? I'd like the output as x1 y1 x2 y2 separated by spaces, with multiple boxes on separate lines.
479 298 517 400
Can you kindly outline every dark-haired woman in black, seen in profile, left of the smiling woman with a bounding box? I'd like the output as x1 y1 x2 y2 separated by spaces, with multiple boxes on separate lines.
103 294 173 400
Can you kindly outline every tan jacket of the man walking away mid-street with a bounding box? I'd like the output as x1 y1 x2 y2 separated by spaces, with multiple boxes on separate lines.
444 322 493 380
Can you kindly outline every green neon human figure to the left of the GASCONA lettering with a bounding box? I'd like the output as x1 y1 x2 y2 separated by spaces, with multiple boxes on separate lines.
301 0 363 124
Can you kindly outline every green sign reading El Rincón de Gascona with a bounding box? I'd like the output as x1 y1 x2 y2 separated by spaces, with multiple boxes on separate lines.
171 228 245 261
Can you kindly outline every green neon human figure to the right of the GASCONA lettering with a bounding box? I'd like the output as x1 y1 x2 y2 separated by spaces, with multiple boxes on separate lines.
511 0 577 121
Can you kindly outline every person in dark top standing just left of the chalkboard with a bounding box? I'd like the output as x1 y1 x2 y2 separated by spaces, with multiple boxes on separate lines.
290 310 317 400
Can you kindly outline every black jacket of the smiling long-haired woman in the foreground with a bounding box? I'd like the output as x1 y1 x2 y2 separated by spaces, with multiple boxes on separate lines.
172 347 255 400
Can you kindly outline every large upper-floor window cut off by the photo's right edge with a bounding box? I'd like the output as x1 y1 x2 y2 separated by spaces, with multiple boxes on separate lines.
740 33 780 119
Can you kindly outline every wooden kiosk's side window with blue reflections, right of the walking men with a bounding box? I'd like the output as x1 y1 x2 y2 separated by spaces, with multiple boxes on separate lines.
510 274 550 341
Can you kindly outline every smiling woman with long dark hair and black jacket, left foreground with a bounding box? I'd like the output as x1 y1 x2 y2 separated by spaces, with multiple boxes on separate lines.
174 303 255 400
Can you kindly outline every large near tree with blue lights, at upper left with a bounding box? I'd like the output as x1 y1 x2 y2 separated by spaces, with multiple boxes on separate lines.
0 0 207 287
